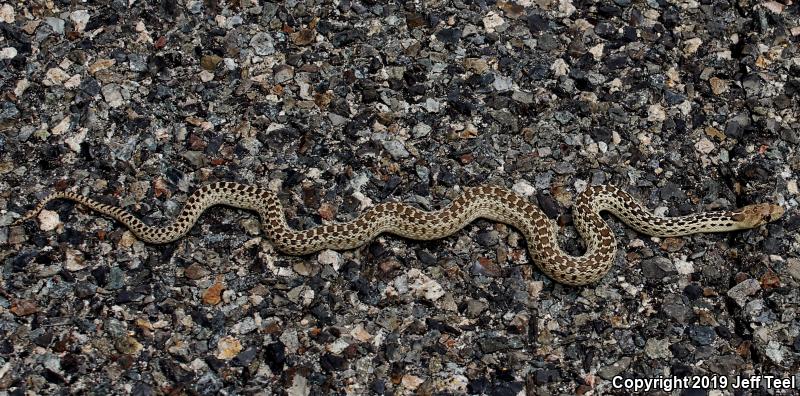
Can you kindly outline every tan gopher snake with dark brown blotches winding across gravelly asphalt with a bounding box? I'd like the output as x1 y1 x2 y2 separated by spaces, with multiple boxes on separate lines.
12 182 783 285
